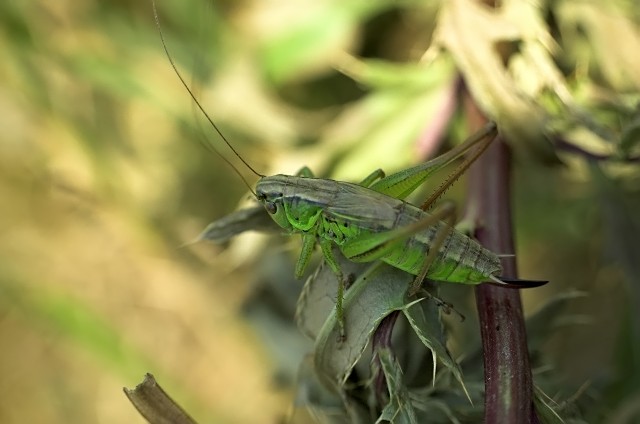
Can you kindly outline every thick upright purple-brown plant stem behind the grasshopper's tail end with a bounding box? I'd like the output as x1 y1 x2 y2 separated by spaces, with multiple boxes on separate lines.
465 97 537 423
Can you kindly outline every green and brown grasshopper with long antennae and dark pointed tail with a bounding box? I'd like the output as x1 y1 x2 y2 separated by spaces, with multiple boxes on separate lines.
152 1 546 337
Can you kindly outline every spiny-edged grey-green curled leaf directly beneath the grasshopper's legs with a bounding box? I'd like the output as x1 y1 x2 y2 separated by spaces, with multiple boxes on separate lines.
308 249 469 397
